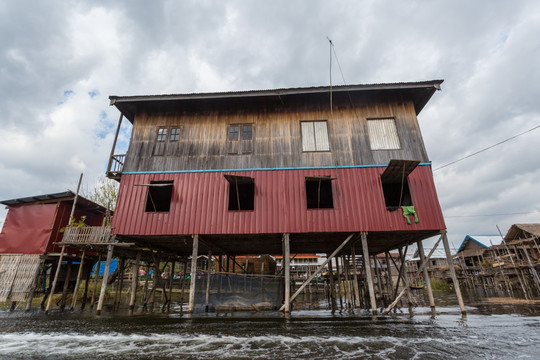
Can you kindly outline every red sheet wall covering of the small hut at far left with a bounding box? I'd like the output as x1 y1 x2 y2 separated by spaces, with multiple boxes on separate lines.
0 204 57 254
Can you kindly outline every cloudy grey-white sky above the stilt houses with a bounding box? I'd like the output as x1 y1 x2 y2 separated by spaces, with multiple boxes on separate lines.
0 0 540 247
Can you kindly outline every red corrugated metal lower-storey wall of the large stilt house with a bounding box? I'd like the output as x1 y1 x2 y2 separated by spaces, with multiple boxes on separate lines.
113 166 445 235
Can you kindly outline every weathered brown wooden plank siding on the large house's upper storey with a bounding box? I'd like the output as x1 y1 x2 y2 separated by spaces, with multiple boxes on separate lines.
124 97 428 172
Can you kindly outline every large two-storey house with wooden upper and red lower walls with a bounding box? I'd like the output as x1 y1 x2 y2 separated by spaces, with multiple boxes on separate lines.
107 80 460 314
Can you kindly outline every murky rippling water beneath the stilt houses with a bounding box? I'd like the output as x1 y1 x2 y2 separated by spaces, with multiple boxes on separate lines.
0 296 540 359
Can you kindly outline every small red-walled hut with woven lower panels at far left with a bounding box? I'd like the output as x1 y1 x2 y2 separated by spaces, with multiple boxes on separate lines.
0 191 106 308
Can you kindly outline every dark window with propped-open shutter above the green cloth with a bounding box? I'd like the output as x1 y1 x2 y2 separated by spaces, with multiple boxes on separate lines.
381 160 420 211
